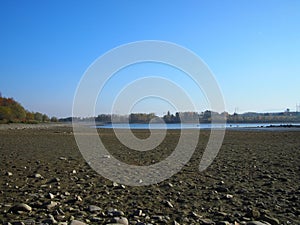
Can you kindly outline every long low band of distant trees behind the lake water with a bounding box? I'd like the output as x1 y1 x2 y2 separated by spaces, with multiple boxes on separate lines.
67 110 300 124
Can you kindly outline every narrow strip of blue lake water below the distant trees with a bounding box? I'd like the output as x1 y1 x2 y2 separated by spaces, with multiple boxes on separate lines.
96 123 300 130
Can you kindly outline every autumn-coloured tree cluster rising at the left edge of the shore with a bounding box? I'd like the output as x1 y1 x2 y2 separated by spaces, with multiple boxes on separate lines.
0 96 58 123
